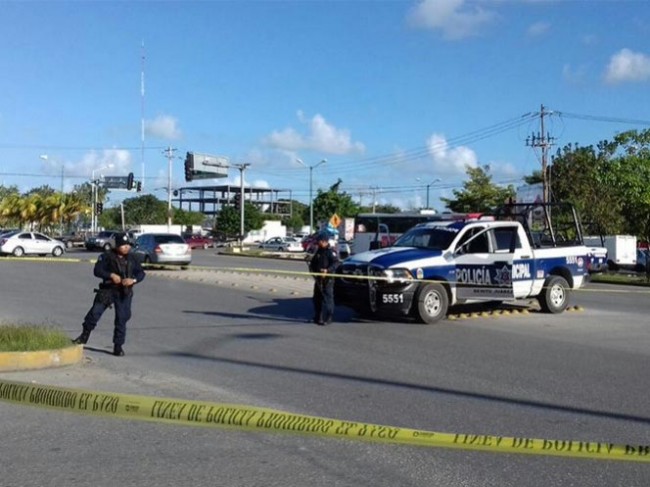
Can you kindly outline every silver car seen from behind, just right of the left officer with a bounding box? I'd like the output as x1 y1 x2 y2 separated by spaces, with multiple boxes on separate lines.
133 233 192 266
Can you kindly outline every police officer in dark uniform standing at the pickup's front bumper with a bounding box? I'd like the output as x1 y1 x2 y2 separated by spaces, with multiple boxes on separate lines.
309 232 339 326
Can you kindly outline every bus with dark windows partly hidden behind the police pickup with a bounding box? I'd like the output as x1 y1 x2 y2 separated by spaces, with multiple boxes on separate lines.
352 210 482 254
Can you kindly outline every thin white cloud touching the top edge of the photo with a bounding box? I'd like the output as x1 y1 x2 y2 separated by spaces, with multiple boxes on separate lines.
407 0 497 40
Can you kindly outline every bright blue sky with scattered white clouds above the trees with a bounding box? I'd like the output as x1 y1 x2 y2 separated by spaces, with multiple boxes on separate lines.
0 0 650 210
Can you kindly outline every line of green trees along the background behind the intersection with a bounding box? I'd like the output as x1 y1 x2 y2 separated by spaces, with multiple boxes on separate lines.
0 130 650 241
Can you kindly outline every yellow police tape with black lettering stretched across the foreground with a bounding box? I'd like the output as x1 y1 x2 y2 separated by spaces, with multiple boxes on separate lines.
0 380 650 463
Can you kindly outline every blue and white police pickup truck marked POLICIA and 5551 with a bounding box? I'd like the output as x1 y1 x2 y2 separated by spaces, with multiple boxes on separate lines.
334 204 604 324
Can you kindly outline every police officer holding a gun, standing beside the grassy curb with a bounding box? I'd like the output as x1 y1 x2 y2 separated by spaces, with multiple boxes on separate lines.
73 233 145 357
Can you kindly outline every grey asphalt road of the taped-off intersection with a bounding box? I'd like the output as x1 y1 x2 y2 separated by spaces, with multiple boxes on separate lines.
0 258 650 487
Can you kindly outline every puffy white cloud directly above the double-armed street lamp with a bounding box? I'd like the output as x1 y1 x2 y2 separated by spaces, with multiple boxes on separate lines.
264 112 365 155
